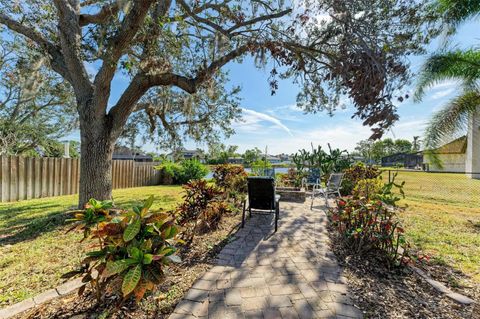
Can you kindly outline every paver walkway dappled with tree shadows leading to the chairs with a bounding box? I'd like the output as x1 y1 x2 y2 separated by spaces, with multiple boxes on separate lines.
170 203 362 319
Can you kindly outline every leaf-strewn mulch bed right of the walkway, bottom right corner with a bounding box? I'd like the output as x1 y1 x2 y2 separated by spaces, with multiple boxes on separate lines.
330 231 480 319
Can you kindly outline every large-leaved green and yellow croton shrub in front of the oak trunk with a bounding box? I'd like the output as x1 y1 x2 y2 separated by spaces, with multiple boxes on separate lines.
63 196 179 302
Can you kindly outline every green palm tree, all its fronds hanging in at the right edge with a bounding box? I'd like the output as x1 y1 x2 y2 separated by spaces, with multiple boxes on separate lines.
414 0 480 166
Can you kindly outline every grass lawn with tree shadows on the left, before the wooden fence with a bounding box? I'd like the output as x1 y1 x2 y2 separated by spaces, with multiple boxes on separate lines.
0 186 181 308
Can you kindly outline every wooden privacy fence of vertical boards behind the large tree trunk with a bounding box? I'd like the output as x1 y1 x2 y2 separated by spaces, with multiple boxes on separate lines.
0 156 161 202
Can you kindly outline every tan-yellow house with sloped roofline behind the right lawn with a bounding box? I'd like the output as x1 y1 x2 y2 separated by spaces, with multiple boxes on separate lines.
424 136 466 173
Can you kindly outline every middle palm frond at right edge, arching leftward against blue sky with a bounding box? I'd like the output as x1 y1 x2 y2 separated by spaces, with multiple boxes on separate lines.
414 49 480 101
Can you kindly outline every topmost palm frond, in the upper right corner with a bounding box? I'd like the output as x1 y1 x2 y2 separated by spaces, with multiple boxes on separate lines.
434 0 480 34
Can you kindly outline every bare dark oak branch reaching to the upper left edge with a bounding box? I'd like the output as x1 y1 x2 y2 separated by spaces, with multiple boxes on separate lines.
0 13 72 83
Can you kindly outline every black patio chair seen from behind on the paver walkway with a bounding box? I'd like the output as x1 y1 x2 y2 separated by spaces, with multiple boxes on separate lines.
242 176 280 232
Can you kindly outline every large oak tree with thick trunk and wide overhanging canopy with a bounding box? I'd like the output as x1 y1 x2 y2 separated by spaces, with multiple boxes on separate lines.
0 0 436 204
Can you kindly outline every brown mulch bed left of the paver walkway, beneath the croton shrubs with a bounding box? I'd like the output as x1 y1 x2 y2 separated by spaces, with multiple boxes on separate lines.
15 214 241 319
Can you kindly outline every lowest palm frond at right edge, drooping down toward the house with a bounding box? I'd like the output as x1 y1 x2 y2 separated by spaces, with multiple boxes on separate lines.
424 90 480 151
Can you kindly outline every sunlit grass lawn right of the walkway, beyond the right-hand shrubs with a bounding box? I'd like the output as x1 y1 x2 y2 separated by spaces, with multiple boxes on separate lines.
383 172 480 283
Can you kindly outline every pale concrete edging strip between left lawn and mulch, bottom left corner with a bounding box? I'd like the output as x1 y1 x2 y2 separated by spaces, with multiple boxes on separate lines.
0 278 84 319
